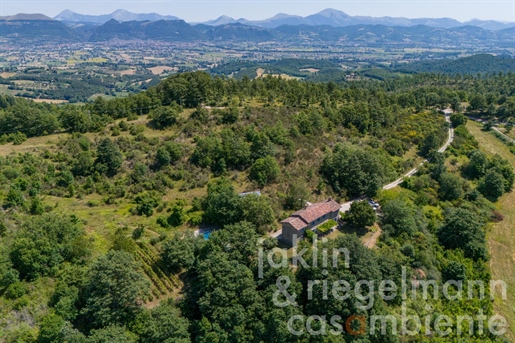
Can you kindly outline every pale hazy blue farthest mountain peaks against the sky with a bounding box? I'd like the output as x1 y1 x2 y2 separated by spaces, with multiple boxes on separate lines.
54 8 515 30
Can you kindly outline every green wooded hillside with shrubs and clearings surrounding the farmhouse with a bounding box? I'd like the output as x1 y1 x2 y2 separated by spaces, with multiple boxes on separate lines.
0 72 515 343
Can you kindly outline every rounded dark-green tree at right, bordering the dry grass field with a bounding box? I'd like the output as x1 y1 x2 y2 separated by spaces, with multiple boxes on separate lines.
438 208 488 261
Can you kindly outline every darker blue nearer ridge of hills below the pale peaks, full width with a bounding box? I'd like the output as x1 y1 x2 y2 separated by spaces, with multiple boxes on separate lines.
0 12 515 48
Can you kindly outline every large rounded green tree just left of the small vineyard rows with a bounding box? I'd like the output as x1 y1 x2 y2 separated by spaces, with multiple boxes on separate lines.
81 251 150 328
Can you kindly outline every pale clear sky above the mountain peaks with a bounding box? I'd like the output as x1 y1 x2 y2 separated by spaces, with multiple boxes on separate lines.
0 0 515 22
